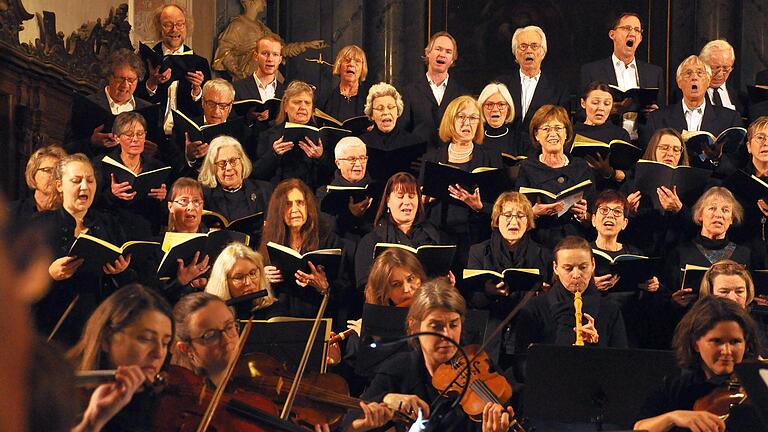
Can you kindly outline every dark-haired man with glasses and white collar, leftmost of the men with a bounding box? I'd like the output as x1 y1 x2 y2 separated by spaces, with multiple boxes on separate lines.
64 49 152 157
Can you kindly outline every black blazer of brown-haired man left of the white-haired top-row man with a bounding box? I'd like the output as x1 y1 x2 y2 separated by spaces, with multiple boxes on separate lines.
400 75 467 147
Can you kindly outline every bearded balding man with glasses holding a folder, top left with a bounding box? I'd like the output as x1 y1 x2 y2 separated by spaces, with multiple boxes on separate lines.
138 4 211 134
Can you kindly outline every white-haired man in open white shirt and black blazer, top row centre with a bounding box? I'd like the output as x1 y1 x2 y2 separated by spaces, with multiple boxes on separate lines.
497 26 570 148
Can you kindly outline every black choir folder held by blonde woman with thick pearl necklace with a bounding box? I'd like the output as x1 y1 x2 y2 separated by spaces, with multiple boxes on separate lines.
423 161 510 203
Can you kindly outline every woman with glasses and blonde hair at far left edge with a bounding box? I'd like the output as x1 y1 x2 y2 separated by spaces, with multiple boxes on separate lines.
8 145 67 224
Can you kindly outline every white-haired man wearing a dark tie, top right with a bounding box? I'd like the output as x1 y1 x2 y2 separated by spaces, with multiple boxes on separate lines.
699 39 744 113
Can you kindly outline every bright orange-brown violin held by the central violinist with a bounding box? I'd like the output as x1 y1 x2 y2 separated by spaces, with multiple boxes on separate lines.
432 345 525 432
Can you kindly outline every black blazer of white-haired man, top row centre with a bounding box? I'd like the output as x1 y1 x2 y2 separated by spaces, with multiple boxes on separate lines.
498 68 570 152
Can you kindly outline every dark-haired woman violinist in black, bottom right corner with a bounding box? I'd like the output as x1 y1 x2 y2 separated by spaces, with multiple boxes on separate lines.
634 296 760 432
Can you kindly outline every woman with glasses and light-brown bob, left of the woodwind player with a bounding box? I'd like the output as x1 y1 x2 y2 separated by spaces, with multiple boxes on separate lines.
467 191 552 367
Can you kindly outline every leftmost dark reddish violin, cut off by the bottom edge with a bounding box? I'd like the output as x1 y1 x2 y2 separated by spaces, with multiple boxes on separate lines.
152 366 306 432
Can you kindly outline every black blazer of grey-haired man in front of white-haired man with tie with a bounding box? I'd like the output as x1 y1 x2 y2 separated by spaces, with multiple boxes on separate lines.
640 102 742 145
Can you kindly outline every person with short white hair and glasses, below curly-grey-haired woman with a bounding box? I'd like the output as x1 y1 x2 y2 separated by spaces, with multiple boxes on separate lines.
317 137 373 242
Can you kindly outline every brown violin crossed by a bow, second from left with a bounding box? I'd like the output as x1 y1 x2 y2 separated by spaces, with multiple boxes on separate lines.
233 353 413 427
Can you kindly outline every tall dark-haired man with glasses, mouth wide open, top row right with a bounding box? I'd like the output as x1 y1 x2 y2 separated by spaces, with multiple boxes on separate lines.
580 12 666 139
